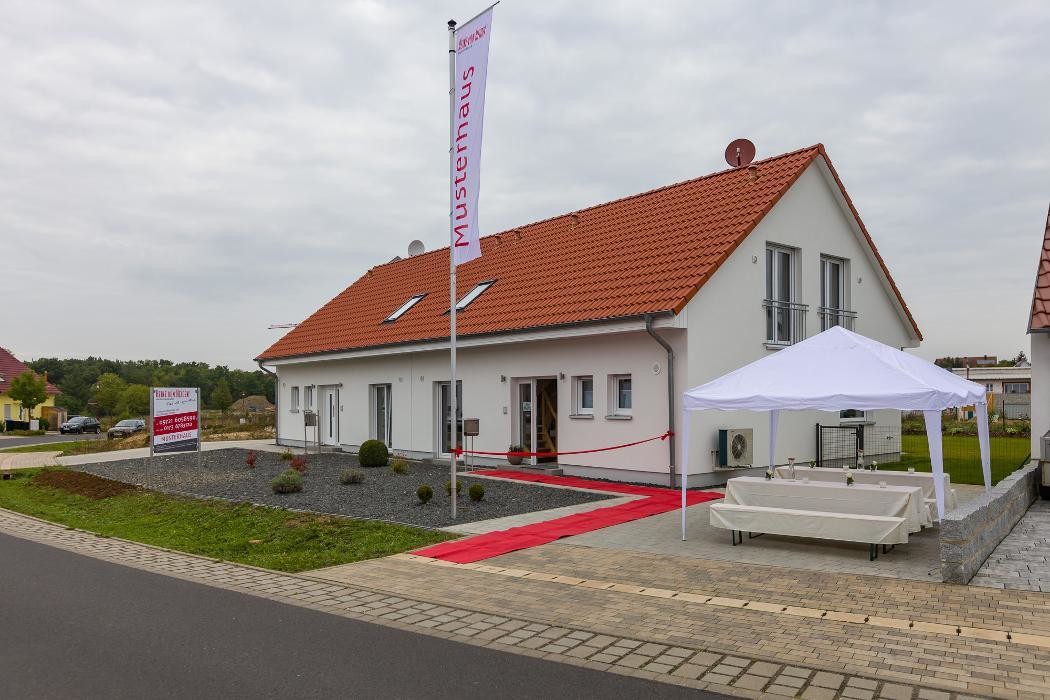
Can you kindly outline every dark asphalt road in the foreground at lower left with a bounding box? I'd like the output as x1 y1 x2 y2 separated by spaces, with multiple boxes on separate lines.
0 534 722 700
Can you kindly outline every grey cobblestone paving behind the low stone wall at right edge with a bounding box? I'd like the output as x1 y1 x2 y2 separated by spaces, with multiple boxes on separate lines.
970 500 1050 593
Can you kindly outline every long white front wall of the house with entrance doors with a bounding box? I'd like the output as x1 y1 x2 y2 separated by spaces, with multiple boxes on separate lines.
277 328 685 481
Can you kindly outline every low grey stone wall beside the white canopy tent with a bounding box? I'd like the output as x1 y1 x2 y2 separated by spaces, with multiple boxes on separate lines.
941 462 1040 584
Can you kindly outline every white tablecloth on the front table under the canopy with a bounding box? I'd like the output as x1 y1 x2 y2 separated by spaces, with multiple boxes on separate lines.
726 475 933 532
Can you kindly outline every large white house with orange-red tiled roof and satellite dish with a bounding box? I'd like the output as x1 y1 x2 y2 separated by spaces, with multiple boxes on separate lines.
256 145 922 484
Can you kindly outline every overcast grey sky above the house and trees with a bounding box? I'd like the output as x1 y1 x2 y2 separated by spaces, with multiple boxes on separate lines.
0 0 1050 367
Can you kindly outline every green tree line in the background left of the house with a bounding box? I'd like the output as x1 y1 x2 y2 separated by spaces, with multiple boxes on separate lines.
28 357 274 417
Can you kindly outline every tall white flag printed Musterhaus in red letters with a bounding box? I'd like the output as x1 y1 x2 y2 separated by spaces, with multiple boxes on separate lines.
452 7 492 264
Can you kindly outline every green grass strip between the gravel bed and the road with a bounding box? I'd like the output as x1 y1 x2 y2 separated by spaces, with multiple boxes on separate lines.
0 469 454 572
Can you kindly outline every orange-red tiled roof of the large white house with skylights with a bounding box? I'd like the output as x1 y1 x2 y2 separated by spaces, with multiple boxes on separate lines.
257 144 922 360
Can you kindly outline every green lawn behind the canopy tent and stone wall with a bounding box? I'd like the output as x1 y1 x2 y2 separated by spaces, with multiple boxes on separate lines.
886 434 1032 484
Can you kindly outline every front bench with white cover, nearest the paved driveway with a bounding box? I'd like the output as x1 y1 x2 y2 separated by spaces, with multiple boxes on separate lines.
711 503 908 560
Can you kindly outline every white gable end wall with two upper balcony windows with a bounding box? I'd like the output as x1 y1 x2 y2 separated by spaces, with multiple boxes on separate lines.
677 158 918 484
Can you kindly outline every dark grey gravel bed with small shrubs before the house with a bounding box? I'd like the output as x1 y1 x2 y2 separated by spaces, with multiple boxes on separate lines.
72 448 614 528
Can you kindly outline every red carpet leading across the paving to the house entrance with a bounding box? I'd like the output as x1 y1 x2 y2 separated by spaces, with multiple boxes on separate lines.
413 469 721 564
